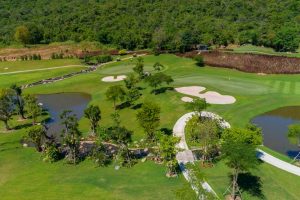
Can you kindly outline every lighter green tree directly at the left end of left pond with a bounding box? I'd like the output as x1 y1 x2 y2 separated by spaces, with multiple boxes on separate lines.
24 94 42 125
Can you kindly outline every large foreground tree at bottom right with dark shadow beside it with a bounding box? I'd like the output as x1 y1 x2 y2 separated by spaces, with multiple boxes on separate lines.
221 128 262 199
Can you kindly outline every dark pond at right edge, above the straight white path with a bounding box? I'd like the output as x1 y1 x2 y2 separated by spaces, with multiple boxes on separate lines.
251 106 300 157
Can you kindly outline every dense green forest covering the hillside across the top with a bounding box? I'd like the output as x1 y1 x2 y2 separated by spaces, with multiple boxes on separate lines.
0 0 300 51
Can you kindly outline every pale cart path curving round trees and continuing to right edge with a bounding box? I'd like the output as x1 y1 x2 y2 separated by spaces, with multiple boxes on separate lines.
173 112 300 196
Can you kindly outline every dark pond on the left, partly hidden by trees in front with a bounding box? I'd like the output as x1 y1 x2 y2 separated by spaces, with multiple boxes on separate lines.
37 93 91 138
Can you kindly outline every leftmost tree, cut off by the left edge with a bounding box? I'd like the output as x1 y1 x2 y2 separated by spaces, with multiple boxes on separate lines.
0 89 15 130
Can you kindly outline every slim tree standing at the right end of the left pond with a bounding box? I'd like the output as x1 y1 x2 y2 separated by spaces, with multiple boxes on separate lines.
84 105 101 136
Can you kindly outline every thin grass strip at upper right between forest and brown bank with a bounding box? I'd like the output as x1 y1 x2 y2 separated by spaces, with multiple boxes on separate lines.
233 45 300 58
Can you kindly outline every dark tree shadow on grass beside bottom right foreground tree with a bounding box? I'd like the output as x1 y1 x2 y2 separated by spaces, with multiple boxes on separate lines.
231 172 265 199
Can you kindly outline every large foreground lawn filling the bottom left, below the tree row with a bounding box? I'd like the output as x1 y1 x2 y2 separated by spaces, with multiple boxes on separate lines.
0 129 186 200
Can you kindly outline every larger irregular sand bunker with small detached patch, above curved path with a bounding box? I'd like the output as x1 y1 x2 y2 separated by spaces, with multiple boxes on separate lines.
175 86 236 104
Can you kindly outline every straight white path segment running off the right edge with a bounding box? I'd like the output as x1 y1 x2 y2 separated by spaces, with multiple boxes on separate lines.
257 149 300 176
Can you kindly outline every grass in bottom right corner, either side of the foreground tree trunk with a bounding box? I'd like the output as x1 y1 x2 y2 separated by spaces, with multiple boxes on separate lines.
198 161 300 200
